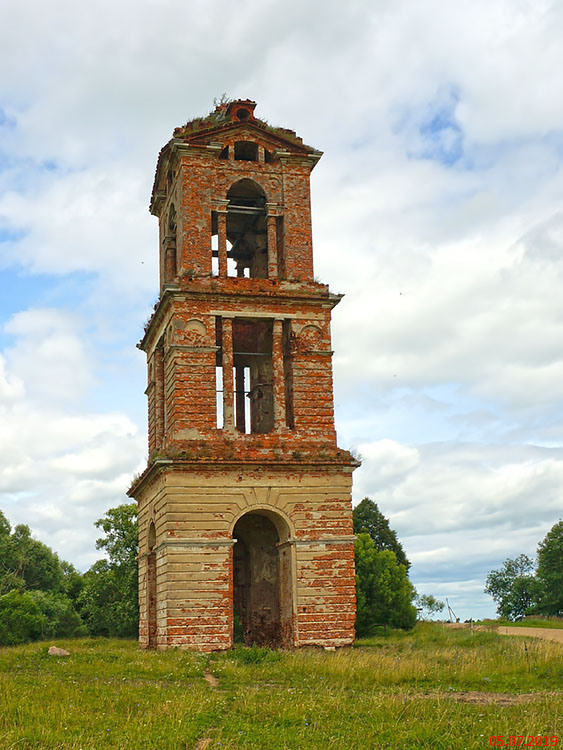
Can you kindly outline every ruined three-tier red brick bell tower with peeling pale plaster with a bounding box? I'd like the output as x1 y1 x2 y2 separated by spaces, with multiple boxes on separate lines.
129 100 358 651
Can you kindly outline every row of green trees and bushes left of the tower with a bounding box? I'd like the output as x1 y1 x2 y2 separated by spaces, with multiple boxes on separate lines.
0 503 138 646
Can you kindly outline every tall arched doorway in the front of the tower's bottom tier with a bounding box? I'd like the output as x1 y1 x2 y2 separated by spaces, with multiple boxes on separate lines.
233 511 294 647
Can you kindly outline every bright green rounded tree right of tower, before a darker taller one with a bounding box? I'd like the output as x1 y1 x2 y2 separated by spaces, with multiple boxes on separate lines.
354 533 416 635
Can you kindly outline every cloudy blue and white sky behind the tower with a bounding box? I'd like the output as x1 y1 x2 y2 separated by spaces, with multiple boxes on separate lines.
0 0 563 619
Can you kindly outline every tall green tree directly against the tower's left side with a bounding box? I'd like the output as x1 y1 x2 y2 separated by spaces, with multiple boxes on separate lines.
78 503 139 637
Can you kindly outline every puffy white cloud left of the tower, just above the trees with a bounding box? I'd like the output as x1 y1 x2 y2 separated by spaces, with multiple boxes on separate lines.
0 309 146 567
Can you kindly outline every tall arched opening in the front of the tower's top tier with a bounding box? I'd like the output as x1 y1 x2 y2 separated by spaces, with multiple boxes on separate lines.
227 179 268 279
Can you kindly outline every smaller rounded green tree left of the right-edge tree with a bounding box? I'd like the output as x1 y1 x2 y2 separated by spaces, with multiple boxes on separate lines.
485 555 540 620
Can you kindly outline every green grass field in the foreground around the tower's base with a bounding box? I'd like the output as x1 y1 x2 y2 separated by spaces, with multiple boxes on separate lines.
0 623 563 750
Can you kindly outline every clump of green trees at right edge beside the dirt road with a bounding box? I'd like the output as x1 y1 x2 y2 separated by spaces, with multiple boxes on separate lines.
485 521 563 620
